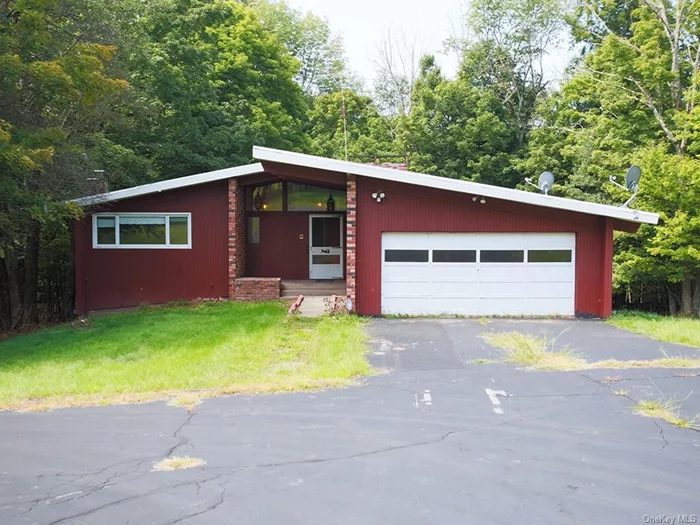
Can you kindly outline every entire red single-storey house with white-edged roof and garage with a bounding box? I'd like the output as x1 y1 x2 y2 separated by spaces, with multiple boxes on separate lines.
74 147 658 317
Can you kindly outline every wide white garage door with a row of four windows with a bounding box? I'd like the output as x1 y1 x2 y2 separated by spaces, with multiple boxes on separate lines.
382 233 576 315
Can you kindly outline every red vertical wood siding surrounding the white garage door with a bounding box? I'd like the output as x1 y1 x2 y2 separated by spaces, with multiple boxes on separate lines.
356 177 612 317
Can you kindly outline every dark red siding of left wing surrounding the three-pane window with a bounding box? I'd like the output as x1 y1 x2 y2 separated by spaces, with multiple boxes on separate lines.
74 180 229 313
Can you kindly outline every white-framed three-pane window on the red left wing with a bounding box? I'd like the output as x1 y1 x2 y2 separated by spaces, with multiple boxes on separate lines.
93 213 192 248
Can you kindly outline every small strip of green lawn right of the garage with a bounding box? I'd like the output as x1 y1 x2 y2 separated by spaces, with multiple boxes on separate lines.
608 312 700 347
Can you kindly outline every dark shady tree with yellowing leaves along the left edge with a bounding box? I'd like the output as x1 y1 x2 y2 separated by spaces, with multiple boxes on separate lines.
0 0 133 330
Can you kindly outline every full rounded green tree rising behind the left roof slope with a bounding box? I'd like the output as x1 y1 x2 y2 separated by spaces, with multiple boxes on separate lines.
120 0 307 178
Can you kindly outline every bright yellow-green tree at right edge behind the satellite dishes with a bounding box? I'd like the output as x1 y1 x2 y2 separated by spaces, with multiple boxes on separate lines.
540 0 700 315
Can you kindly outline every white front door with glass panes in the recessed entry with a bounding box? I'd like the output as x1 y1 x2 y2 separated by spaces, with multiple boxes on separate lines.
309 215 344 279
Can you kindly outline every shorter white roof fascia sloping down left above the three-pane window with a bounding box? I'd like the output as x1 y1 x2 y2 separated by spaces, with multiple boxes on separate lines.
72 162 265 206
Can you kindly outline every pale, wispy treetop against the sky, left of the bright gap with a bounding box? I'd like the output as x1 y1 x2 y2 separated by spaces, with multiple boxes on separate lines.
250 0 351 96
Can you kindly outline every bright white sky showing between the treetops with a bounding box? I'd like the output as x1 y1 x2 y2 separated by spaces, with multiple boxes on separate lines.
287 0 569 87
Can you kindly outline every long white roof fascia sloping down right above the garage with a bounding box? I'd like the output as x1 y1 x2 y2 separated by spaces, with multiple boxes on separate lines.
253 146 659 224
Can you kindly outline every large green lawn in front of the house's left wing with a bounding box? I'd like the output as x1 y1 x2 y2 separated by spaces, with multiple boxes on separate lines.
0 303 370 409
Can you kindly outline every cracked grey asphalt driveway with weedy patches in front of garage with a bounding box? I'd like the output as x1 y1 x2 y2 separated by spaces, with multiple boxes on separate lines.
0 319 700 525
